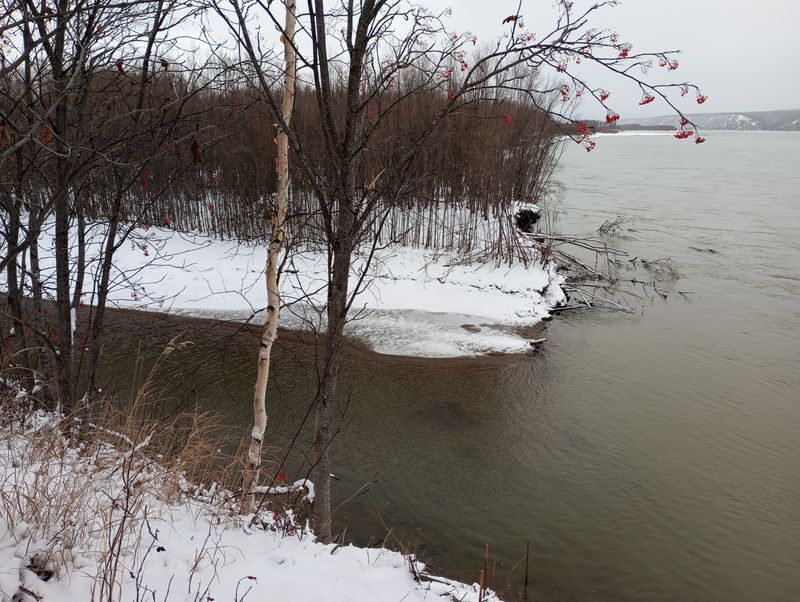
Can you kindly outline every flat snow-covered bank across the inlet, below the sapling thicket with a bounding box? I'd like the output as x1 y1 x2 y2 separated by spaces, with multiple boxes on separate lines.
0 225 564 357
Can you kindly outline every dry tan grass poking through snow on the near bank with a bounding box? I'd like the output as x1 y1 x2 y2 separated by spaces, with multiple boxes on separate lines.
0 346 238 602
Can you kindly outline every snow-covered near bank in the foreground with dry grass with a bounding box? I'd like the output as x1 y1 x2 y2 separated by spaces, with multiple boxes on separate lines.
0 404 497 602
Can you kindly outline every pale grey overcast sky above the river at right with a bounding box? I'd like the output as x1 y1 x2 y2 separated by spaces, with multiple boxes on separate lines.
422 0 800 118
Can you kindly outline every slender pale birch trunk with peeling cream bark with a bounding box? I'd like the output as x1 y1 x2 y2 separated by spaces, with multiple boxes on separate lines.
241 0 296 514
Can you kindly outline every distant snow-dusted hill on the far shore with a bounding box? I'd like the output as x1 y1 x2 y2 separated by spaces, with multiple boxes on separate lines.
619 109 800 132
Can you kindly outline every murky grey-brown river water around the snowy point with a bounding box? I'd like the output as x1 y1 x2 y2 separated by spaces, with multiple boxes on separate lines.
101 132 800 600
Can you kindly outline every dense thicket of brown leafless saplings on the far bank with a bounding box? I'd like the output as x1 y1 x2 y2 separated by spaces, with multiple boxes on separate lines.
0 64 560 261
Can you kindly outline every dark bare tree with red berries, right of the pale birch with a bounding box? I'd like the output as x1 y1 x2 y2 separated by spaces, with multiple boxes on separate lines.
215 0 705 541
